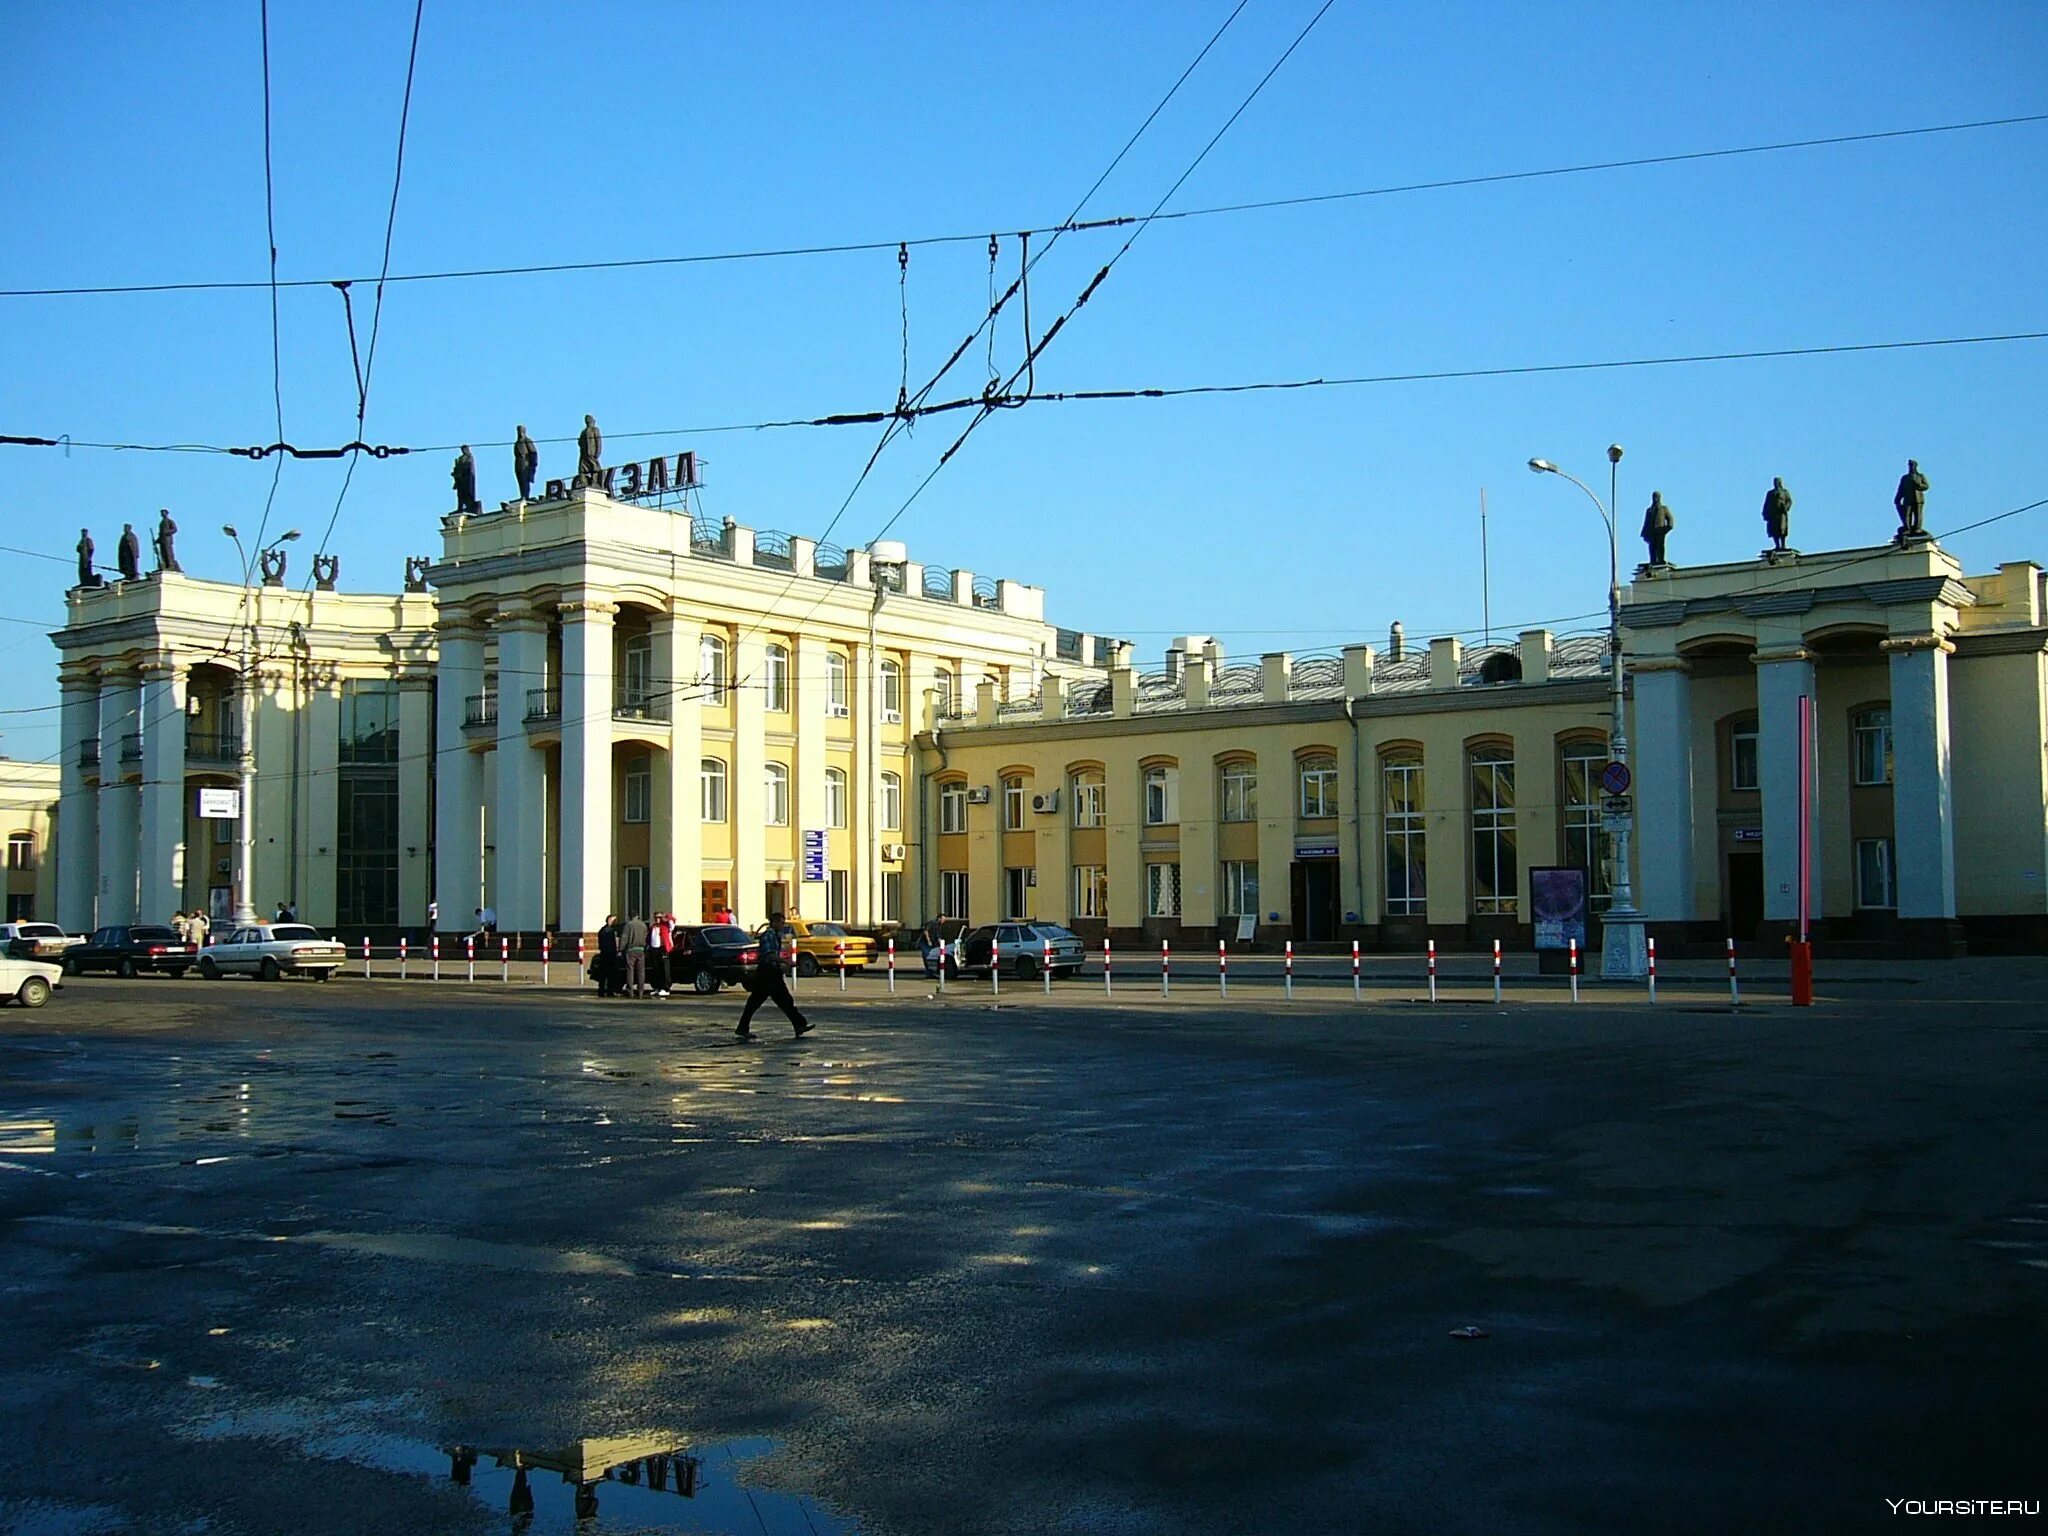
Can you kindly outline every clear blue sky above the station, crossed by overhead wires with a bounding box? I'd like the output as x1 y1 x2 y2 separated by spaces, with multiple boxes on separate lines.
0 0 2048 758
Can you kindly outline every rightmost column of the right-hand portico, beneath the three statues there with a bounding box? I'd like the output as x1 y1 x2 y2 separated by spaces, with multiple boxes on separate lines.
1884 635 1956 920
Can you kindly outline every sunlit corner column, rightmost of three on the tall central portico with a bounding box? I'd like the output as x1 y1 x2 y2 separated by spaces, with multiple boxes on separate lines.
561 598 610 934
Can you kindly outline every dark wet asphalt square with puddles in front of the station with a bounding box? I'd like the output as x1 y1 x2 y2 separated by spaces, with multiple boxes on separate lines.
0 961 2048 1536
